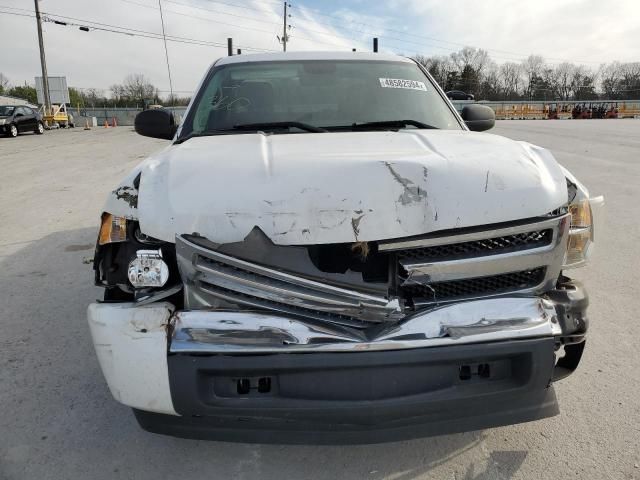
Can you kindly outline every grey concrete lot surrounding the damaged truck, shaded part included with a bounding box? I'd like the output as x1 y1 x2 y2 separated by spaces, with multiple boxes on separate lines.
0 120 640 480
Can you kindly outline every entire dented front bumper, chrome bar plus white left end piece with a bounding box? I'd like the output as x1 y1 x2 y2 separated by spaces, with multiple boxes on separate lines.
88 282 588 415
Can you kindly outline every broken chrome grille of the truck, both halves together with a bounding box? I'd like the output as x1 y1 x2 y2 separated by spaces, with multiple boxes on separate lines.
176 215 569 329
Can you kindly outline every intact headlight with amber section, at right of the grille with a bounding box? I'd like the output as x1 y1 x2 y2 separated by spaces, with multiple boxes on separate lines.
563 197 604 269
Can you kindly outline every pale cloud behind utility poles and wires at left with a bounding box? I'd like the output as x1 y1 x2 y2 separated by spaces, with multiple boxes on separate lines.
0 0 360 95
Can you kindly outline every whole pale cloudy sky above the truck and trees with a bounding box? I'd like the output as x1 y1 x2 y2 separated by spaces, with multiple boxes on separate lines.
0 0 640 95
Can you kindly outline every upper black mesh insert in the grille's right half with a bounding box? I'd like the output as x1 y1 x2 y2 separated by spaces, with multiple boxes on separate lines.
397 228 553 260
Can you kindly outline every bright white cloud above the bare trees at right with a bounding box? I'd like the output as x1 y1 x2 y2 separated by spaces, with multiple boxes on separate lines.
389 0 640 66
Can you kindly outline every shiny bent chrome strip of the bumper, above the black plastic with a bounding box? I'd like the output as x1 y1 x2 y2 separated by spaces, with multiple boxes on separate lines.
169 297 562 354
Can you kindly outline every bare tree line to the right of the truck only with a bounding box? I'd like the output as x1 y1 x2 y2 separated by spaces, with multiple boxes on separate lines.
414 47 640 101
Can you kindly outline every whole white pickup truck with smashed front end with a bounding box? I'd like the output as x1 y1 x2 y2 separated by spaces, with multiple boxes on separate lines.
88 52 603 443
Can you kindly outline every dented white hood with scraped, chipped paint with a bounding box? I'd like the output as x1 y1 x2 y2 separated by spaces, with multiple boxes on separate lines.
124 130 567 245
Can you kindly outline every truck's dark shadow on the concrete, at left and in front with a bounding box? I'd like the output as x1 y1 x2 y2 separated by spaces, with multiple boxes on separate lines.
0 228 527 480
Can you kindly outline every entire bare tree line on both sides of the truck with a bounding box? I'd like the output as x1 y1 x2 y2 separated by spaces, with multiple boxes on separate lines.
0 47 640 108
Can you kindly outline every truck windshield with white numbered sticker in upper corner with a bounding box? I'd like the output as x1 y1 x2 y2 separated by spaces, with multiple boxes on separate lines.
181 60 462 137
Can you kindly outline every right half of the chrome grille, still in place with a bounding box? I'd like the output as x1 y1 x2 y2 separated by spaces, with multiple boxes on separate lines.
390 215 569 304
